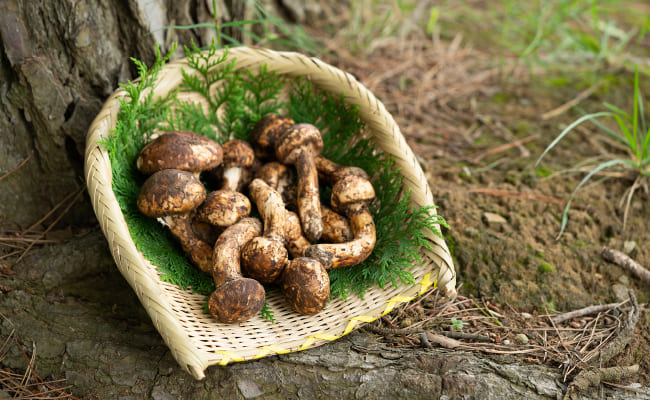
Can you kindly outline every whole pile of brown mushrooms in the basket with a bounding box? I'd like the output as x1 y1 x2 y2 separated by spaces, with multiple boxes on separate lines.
136 114 375 323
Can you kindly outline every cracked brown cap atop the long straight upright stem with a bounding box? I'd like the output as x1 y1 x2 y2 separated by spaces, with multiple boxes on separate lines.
275 124 323 164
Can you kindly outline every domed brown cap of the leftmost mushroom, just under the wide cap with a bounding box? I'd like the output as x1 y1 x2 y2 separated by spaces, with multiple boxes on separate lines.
137 169 206 218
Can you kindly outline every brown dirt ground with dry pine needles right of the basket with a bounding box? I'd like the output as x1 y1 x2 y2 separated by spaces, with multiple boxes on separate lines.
310 19 650 385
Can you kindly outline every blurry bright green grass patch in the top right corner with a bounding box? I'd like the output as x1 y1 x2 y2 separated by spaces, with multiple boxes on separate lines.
495 0 648 76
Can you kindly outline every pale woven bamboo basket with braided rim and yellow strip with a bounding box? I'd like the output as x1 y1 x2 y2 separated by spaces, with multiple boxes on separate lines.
85 47 456 379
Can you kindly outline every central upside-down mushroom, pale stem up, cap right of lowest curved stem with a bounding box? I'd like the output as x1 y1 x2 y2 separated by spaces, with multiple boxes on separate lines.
241 179 289 283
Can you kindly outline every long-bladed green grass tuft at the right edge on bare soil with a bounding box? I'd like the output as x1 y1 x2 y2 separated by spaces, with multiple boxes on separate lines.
535 70 650 238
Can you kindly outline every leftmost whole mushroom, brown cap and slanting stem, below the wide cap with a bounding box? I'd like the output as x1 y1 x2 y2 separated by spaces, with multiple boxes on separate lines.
136 169 212 273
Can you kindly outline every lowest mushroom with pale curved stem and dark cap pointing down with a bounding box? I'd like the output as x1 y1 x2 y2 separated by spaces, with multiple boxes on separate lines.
208 218 266 324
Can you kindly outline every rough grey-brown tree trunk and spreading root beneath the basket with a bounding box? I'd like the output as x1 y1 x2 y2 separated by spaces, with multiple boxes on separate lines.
0 0 640 399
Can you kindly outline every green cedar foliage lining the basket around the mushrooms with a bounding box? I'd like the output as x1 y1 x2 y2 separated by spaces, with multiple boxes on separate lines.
103 43 446 304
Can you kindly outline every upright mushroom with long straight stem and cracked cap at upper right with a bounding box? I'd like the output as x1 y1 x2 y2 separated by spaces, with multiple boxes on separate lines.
275 124 323 242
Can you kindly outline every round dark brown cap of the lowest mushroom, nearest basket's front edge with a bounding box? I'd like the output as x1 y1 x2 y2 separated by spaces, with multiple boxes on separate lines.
208 278 266 324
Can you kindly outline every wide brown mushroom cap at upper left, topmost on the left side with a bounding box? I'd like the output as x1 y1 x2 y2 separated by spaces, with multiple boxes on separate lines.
136 131 223 175
